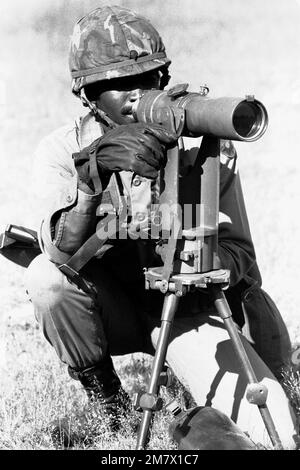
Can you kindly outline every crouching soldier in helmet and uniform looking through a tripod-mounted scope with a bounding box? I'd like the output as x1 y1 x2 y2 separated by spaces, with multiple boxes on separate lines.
27 6 294 448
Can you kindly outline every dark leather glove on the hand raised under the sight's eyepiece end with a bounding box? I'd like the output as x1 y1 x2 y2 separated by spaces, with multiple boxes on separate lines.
73 123 178 191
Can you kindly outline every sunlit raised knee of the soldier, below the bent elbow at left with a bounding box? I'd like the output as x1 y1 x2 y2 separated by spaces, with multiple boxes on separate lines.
25 254 67 307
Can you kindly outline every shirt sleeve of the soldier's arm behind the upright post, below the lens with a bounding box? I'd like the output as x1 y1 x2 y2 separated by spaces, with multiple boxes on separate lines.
218 141 260 286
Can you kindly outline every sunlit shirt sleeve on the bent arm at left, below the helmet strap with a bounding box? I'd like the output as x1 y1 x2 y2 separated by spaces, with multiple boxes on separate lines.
33 125 101 264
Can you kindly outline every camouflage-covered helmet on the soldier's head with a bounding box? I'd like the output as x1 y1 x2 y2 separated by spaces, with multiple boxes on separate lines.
69 6 171 94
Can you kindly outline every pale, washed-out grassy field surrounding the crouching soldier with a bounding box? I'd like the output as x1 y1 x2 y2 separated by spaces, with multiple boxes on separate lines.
0 0 300 449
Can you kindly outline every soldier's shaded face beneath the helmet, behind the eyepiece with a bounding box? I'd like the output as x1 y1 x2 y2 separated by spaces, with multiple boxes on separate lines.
96 71 160 124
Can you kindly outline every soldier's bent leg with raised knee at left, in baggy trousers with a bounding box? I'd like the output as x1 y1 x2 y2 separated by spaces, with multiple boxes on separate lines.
26 255 144 445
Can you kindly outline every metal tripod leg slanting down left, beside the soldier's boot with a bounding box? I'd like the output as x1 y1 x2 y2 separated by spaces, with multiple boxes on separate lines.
136 292 179 450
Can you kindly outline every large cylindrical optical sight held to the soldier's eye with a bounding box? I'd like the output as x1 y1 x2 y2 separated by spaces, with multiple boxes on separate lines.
132 84 268 142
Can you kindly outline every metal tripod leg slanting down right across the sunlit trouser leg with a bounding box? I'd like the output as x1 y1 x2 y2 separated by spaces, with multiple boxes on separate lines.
210 284 283 450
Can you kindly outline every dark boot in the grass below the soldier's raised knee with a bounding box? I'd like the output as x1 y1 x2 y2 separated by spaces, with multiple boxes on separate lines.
50 356 132 448
